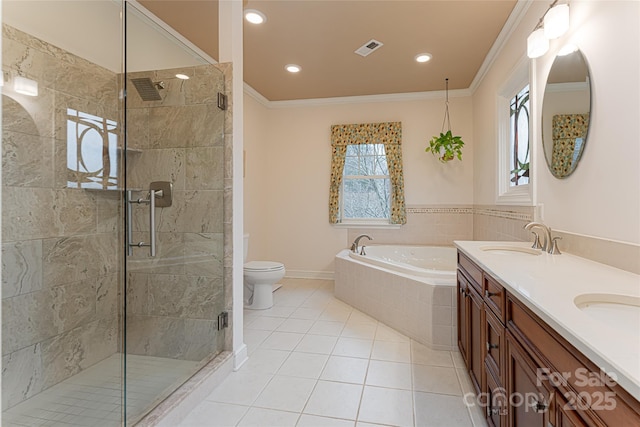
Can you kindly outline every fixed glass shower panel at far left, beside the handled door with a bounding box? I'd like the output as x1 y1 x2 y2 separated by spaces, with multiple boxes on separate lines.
2 0 124 426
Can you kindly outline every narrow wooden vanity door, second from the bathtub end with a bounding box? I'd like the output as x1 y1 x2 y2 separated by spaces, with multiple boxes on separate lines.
467 286 485 393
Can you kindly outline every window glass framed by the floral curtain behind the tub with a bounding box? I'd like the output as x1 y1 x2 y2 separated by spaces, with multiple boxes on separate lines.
340 144 391 222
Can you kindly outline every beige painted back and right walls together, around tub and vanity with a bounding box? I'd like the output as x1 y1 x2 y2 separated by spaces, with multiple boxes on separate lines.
245 1 640 272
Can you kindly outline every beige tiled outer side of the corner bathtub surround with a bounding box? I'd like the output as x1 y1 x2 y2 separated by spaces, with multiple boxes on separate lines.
335 250 457 350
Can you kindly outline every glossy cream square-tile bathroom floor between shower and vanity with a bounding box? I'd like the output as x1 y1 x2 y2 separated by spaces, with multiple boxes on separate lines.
180 279 486 427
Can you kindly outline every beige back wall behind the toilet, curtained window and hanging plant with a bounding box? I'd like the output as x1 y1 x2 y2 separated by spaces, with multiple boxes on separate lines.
244 94 473 273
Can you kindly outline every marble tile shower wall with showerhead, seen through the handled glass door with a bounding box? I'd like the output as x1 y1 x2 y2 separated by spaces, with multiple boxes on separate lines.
127 65 225 361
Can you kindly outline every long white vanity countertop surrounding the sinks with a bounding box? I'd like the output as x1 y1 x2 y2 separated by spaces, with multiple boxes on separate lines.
454 241 640 400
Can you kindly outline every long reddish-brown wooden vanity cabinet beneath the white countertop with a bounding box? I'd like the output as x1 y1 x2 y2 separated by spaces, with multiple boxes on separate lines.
457 251 640 427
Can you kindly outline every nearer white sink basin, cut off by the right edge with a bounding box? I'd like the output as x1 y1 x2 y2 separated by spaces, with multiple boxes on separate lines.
573 294 640 328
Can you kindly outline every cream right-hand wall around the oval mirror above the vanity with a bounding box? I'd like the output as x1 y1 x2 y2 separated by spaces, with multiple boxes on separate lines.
473 1 640 245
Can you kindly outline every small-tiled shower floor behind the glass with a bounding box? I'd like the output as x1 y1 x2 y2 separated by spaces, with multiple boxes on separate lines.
2 354 198 427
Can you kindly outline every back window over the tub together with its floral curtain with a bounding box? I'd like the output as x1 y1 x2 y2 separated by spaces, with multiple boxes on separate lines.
329 122 406 225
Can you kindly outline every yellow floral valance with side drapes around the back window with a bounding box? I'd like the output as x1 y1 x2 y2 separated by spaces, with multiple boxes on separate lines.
329 122 407 224
